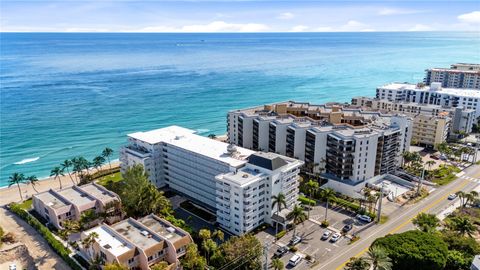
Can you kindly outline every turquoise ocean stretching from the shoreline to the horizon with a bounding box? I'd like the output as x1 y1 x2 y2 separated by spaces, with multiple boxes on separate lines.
0 33 480 186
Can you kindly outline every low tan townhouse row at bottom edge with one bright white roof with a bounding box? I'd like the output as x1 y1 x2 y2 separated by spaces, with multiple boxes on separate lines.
80 214 193 270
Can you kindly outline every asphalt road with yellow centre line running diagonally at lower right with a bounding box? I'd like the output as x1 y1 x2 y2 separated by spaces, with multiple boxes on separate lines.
314 165 480 270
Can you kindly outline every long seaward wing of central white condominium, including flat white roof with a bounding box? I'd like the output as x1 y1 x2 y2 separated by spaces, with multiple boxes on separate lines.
120 126 254 210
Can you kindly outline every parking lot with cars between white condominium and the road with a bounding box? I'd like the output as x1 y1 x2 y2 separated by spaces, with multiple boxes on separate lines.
256 206 374 269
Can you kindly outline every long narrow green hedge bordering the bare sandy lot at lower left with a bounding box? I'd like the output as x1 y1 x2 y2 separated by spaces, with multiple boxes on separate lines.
10 203 82 270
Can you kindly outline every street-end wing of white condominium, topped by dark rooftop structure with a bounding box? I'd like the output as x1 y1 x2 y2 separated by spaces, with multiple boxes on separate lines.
216 152 303 234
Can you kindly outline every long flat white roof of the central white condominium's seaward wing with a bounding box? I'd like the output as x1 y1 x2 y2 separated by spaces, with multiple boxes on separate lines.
128 126 255 167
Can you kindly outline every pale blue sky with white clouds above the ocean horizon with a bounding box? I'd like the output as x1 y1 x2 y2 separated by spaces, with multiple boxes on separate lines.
0 0 480 33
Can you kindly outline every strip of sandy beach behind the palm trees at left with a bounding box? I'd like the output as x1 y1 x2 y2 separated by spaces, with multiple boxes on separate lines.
0 161 120 206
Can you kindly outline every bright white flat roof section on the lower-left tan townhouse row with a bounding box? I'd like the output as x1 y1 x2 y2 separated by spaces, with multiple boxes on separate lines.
85 225 134 257
